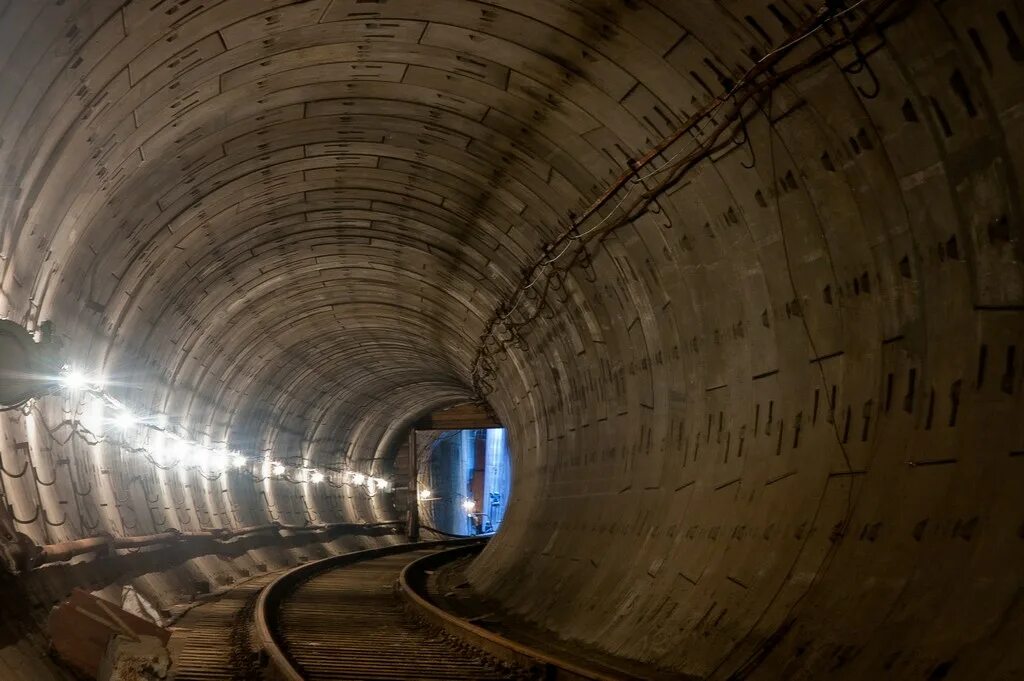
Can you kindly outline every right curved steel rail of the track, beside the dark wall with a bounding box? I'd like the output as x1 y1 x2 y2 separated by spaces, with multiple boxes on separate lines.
398 545 623 681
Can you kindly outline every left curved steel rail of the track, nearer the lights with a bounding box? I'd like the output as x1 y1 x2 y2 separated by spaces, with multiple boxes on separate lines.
255 538 499 681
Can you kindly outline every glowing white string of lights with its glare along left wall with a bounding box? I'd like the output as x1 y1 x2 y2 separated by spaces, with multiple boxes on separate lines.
47 365 391 496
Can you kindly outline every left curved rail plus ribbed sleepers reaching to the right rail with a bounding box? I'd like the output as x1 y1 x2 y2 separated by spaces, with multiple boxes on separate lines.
256 542 527 681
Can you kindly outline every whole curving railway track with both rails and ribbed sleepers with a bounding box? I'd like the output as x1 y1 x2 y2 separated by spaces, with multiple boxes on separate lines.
169 540 622 681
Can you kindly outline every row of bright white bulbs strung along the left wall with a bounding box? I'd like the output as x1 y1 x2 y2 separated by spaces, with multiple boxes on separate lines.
59 367 391 494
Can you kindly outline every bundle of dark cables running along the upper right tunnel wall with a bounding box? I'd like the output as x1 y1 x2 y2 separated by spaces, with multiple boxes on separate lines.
472 0 899 398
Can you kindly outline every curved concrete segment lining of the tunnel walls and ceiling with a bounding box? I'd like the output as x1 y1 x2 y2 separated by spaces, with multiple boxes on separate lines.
0 0 1024 681
